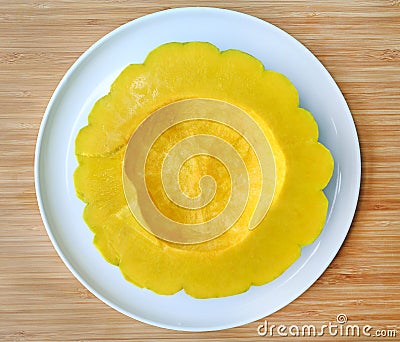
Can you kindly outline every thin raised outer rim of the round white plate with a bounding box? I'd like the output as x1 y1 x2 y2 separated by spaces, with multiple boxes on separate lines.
34 6 362 332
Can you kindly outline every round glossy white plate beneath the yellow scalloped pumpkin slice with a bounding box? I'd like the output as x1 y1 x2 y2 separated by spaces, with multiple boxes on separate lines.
35 7 361 331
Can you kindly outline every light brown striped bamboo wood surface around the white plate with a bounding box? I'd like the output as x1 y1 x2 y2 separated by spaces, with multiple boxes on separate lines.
0 0 400 341
